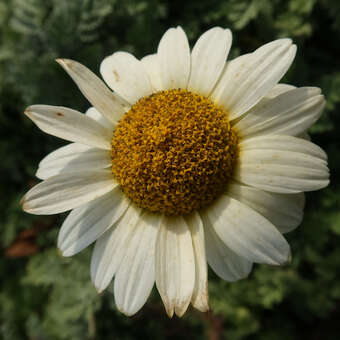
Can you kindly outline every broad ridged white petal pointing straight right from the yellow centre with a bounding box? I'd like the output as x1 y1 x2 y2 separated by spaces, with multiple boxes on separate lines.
234 135 329 194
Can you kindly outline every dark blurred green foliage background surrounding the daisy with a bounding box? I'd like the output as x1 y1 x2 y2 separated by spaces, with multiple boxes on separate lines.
0 0 340 340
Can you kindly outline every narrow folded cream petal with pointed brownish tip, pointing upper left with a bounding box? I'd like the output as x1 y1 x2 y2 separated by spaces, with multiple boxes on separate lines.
57 59 129 125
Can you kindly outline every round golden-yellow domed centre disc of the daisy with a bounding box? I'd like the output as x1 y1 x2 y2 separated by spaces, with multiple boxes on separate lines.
111 89 238 215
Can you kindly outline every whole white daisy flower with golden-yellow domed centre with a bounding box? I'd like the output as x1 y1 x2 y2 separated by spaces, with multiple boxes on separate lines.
22 27 329 317
